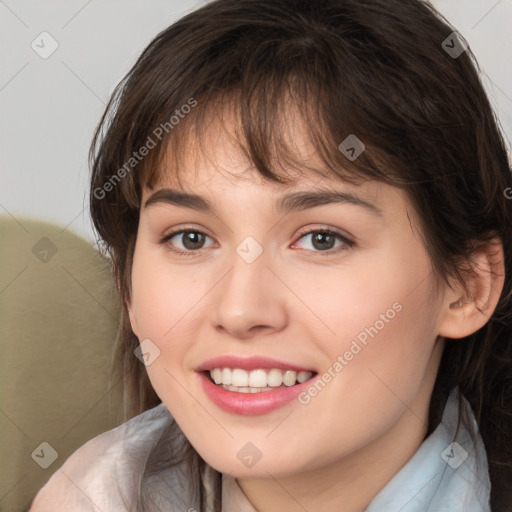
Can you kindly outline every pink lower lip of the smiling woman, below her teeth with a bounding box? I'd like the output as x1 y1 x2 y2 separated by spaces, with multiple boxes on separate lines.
198 372 314 416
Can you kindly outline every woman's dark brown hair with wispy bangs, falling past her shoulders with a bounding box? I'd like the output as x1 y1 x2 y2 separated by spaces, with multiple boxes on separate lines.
90 0 512 512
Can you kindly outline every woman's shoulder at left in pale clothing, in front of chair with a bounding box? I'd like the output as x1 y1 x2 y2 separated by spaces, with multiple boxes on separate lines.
29 404 172 512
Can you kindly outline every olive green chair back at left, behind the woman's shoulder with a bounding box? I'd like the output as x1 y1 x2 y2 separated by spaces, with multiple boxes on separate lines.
0 217 123 512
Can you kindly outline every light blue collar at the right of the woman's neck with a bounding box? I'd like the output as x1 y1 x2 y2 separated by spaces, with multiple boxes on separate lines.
365 389 491 512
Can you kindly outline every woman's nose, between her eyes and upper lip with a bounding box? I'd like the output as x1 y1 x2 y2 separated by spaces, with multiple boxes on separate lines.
213 241 288 340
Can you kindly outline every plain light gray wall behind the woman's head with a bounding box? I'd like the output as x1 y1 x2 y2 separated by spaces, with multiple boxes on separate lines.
0 0 512 241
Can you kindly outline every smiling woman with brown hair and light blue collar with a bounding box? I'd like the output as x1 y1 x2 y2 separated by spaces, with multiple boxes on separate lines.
31 0 512 512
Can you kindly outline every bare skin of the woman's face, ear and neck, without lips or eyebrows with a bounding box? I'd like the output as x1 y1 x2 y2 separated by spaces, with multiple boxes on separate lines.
129 106 500 512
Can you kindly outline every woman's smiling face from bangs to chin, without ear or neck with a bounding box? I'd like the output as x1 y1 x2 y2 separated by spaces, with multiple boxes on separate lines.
130 109 443 478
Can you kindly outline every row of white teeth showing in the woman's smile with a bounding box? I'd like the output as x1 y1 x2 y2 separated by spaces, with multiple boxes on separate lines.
210 368 313 393
